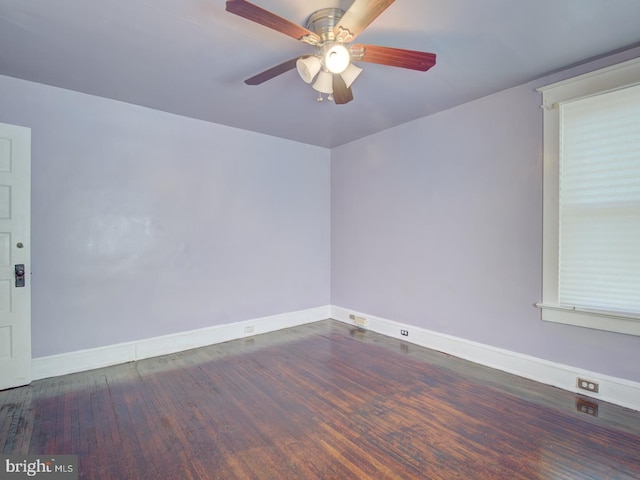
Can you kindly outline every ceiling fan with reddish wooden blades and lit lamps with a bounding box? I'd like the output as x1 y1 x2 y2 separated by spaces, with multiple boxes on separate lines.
227 0 436 105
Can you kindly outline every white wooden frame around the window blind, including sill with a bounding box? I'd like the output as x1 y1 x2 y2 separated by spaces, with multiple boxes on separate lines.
536 58 640 335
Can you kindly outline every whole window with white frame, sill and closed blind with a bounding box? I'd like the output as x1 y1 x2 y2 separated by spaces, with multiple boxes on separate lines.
537 59 640 335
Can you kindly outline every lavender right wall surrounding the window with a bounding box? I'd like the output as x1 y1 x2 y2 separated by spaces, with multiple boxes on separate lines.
331 51 640 381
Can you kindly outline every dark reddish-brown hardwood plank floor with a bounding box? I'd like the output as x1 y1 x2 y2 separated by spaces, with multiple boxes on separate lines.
0 321 640 480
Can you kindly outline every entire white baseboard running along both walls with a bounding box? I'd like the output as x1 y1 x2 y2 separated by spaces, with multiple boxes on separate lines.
32 305 640 411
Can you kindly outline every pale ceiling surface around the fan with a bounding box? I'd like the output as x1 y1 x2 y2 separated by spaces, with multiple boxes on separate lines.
0 0 640 147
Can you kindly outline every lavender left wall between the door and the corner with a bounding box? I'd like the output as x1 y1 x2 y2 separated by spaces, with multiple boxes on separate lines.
0 77 330 357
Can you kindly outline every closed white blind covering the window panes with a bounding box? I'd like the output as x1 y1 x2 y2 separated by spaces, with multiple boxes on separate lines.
558 85 640 314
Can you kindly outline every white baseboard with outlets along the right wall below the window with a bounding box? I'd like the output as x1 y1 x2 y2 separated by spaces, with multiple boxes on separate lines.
331 306 640 410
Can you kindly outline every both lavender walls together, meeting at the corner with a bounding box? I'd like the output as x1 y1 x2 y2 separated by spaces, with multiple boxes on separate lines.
0 49 640 381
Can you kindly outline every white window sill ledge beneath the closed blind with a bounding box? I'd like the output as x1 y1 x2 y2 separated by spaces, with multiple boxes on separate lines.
536 303 640 336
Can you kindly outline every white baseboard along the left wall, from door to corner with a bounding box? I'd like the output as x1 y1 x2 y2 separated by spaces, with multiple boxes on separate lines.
31 305 331 380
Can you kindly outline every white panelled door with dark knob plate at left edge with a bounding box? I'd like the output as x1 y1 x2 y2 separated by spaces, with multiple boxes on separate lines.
0 123 31 390
